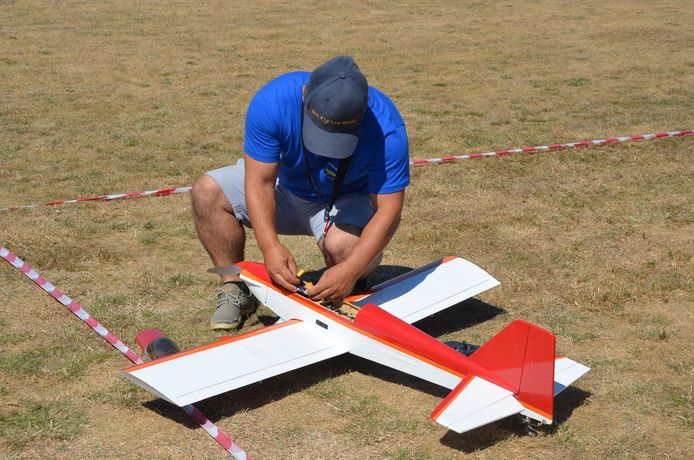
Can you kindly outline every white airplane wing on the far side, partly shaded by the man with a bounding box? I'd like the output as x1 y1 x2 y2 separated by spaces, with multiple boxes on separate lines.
354 257 499 324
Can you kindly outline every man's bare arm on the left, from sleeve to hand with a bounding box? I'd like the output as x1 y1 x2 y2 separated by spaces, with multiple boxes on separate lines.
244 154 299 291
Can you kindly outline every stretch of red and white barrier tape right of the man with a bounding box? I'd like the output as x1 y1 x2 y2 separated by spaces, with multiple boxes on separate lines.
410 129 694 166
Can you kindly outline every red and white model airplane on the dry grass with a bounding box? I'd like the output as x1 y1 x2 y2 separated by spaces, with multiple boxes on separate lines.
123 257 589 433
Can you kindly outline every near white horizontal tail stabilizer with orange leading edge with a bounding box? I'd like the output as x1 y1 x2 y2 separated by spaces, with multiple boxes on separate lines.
431 375 524 433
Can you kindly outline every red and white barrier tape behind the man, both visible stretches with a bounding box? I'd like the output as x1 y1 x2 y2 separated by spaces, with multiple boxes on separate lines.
0 129 694 212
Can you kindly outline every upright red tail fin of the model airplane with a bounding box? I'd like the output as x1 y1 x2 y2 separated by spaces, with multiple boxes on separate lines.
470 320 555 424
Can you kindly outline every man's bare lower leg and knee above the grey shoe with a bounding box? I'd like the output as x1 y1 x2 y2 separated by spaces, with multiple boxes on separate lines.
190 175 246 282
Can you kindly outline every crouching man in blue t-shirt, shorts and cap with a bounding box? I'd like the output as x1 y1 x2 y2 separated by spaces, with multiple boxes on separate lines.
191 56 410 329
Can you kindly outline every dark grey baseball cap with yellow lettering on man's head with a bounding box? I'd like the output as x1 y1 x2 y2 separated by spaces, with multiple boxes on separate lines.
302 56 369 159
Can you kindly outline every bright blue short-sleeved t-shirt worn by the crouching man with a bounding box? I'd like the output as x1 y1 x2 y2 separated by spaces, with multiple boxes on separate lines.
244 72 410 202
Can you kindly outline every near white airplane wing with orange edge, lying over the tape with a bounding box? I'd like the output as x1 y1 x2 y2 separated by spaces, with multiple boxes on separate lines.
123 320 347 406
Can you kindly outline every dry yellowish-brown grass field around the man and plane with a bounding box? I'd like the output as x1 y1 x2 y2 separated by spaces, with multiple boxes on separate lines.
0 0 694 460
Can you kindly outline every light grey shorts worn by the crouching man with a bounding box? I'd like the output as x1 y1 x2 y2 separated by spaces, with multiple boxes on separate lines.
206 159 373 241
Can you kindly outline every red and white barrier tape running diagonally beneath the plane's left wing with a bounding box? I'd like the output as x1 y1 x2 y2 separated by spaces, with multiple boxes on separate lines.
0 246 252 460
